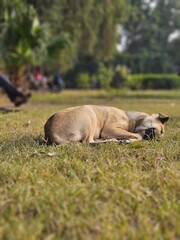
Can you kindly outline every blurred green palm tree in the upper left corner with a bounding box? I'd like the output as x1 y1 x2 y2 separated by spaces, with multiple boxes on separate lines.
0 0 46 84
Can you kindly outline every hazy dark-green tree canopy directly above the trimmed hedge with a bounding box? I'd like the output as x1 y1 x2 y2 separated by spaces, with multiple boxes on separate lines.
123 0 180 72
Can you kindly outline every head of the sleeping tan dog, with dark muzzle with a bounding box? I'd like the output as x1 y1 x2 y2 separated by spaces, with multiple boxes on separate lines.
134 113 169 140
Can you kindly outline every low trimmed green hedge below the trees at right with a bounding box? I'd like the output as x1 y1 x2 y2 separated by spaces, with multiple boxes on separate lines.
127 74 180 90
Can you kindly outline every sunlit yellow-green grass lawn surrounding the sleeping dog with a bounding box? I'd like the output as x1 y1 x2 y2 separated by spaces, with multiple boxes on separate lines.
0 91 180 240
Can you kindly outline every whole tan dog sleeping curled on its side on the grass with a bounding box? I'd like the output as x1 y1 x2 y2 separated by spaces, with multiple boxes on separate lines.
44 105 169 144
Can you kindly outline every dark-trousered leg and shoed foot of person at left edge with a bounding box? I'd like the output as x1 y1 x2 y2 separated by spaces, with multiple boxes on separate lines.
0 72 31 107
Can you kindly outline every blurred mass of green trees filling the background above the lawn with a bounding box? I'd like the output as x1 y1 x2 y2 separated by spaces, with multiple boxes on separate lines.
0 0 180 87
